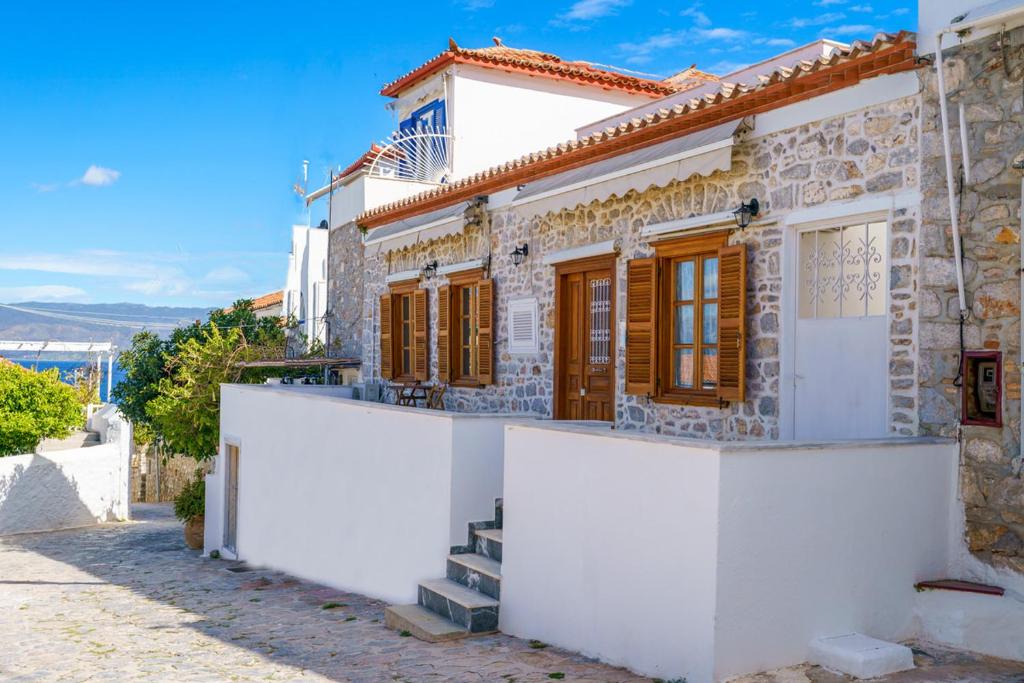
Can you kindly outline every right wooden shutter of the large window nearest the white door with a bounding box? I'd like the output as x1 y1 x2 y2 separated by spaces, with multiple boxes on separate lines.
718 245 746 400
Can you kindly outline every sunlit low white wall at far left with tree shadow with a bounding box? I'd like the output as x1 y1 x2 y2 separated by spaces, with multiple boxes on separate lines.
0 416 131 536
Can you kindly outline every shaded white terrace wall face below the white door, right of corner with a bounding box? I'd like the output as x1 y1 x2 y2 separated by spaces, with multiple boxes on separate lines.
716 441 957 679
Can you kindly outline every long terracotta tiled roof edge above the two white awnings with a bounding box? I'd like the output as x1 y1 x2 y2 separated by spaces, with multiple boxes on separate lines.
356 31 915 228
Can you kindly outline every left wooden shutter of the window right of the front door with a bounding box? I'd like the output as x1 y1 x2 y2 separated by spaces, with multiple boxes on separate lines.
626 258 657 395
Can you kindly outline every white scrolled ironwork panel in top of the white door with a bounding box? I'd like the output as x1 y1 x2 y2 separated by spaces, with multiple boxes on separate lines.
799 221 889 318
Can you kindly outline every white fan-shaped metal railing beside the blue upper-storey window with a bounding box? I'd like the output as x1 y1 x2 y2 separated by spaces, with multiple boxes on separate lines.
370 126 453 184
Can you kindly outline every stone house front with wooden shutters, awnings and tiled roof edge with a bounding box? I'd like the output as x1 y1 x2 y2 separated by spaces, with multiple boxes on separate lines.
357 34 921 439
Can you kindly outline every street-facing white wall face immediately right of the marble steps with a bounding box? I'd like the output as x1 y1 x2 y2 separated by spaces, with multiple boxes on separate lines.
501 425 719 683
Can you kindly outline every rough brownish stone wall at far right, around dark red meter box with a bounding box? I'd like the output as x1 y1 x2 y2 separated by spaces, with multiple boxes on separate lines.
920 29 1024 571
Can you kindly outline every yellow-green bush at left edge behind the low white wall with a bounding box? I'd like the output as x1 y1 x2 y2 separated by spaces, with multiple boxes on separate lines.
0 362 84 456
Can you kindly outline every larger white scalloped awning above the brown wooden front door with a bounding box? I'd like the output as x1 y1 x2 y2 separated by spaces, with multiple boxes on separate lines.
512 119 750 216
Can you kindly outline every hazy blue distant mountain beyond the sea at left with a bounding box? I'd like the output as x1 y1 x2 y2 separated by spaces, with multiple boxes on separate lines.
0 301 212 358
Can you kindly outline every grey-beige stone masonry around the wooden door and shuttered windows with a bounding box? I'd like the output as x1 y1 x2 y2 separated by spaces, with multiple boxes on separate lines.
362 97 920 439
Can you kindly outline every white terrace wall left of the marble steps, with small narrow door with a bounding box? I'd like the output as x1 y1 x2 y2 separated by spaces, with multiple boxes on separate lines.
206 385 510 602
